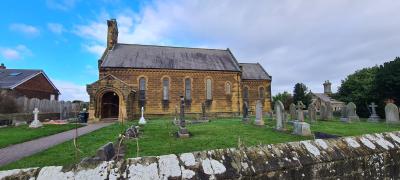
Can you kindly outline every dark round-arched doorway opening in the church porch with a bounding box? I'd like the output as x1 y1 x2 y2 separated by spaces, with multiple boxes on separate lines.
101 92 119 119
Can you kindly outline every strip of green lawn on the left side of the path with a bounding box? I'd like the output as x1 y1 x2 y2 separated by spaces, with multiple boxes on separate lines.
0 124 82 148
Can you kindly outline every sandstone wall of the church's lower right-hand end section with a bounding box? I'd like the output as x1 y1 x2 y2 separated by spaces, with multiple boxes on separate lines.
242 80 272 114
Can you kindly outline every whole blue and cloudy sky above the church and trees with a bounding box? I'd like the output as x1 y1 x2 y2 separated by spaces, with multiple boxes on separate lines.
0 0 400 101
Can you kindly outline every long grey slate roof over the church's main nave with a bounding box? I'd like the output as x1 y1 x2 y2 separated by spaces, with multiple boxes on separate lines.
101 43 240 71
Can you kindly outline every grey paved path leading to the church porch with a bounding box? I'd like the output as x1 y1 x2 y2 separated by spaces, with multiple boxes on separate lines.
0 123 113 166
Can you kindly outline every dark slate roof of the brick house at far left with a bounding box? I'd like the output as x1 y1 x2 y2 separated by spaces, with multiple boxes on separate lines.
0 69 58 91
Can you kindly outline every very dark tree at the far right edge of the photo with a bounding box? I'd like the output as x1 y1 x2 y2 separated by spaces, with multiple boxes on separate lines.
374 57 400 117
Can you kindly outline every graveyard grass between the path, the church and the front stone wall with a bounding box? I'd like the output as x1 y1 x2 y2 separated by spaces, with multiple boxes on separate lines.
0 118 400 170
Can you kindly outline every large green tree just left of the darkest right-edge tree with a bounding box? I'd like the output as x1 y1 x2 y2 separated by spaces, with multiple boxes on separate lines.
334 66 378 118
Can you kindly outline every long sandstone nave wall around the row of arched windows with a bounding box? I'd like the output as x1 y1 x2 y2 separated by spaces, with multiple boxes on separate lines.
99 68 244 115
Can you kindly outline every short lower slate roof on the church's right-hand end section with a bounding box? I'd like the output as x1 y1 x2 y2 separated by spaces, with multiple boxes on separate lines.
240 63 272 80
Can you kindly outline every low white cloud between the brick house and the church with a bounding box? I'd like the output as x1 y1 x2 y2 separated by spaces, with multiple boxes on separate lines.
53 80 89 101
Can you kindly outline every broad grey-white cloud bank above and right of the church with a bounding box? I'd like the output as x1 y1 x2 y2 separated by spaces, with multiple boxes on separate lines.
73 0 400 93
